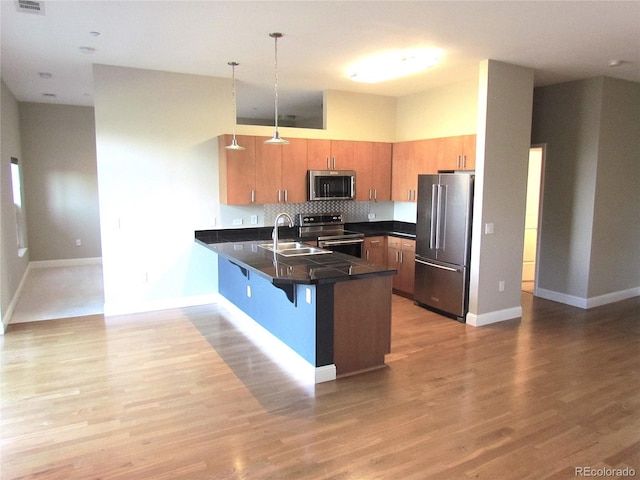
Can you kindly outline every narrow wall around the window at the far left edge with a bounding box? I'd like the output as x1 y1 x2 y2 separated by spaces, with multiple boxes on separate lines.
0 80 29 334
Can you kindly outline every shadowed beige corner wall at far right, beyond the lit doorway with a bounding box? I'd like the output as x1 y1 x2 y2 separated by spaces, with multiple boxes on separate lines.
532 77 640 308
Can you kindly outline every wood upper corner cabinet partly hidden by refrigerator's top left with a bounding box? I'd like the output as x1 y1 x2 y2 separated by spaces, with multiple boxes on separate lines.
391 139 438 202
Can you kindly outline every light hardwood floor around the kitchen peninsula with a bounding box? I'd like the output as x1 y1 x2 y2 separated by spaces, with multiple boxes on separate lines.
0 293 640 480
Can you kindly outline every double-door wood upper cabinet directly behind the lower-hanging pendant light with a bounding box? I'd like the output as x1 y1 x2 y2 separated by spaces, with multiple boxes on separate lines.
255 137 307 204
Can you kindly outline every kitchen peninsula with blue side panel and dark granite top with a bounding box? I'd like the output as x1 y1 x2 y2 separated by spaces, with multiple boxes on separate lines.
196 237 396 383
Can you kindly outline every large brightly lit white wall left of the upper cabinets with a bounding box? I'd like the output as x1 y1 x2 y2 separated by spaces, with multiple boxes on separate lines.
94 65 222 314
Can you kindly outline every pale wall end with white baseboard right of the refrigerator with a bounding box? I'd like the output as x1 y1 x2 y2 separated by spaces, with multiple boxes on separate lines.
467 60 533 325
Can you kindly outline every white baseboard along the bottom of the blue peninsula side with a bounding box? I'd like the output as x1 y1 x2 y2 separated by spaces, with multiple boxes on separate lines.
218 295 336 385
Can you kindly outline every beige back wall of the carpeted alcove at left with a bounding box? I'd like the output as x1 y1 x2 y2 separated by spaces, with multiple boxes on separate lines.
20 103 102 261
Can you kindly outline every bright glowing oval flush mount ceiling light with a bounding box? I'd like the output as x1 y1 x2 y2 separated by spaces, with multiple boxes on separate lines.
349 50 440 83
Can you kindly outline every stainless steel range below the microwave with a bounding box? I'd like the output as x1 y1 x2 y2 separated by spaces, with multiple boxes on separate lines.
296 213 364 258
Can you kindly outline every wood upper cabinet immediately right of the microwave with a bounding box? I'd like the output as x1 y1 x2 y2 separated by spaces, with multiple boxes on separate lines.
353 142 391 202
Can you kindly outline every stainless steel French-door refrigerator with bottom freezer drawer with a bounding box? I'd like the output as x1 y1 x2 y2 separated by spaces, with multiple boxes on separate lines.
414 173 475 322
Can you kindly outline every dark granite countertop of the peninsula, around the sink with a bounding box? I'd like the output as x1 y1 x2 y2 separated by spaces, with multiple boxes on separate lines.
196 237 397 284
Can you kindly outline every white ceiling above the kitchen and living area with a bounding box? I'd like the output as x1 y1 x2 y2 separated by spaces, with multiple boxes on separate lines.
0 0 640 121
